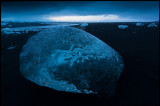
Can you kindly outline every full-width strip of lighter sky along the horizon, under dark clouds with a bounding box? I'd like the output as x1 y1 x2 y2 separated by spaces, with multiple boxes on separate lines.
1 14 159 23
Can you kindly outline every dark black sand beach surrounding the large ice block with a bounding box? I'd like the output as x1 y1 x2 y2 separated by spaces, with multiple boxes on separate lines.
1 23 159 106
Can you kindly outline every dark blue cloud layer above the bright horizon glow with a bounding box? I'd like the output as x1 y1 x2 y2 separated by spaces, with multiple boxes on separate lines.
1 1 159 20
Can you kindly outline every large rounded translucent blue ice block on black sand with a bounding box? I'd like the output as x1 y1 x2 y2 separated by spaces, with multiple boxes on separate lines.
20 27 124 96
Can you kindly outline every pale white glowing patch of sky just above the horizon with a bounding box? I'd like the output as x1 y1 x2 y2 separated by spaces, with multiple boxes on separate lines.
46 15 133 22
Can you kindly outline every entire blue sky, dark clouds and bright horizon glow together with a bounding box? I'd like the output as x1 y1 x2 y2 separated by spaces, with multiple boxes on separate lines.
1 1 159 22
